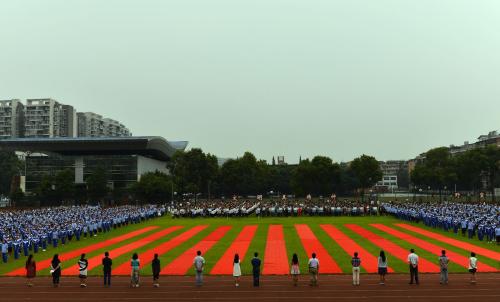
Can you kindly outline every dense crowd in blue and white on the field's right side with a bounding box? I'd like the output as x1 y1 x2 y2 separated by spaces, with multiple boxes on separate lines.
381 202 500 244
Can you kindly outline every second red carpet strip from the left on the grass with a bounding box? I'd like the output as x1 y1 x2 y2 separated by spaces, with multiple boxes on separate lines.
62 226 183 276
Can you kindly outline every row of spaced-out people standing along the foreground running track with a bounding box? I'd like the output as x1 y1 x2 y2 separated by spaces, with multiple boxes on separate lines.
21 249 478 288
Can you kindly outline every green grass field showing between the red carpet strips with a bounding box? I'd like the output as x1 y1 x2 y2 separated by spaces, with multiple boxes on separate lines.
0 216 500 275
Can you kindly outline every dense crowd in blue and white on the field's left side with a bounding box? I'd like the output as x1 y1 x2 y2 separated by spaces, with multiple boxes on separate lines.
0 205 166 263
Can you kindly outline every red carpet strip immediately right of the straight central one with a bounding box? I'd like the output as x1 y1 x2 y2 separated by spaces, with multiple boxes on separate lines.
294 224 342 274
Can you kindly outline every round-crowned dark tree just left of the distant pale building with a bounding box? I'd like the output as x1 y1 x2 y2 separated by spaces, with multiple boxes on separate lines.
350 154 382 200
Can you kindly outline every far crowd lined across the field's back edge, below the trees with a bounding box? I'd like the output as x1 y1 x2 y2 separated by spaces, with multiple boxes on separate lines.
169 198 378 218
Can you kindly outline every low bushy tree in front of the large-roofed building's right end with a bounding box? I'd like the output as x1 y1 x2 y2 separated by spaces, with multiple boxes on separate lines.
131 171 173 203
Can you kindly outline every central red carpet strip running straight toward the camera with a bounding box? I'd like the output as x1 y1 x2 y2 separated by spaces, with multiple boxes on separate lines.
262 225 289 275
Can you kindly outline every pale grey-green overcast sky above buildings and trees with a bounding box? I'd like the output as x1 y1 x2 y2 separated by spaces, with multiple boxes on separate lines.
0 0 500 163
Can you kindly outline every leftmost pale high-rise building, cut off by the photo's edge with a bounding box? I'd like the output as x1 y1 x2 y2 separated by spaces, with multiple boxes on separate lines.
0 99 24 139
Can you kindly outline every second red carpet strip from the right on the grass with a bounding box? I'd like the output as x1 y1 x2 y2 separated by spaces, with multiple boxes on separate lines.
370 223 498 272
